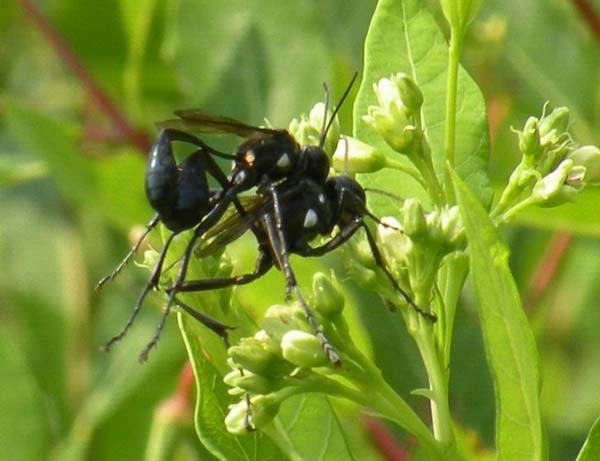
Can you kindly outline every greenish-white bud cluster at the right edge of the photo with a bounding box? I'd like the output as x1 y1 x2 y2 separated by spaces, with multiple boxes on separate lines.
492 107 600 220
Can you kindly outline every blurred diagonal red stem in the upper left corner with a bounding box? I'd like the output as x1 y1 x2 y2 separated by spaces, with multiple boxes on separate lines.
19 0 150 154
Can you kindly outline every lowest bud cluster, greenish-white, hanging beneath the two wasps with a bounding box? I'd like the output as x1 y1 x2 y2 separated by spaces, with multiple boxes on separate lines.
224 273 347 434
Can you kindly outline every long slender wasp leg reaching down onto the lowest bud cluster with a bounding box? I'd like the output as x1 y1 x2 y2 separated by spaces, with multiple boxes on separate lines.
263 184 340 366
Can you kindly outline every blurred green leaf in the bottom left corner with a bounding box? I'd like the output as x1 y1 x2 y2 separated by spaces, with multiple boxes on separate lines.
0 325 48 461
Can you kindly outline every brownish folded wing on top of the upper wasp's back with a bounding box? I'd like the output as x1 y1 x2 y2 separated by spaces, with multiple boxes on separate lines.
156 109 277 138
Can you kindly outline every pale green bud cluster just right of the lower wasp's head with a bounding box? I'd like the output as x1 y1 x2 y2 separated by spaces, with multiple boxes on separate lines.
349 199 466 312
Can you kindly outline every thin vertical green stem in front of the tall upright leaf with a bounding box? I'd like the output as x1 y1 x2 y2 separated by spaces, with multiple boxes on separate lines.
444 28 463 202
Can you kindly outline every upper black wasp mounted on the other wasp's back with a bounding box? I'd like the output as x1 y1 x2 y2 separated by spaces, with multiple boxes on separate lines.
97 79 354 360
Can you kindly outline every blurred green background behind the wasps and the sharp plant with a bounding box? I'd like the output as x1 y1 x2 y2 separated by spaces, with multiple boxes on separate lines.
0 0 600 461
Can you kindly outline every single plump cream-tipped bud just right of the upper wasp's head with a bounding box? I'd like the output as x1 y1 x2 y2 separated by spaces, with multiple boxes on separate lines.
332 136 386 174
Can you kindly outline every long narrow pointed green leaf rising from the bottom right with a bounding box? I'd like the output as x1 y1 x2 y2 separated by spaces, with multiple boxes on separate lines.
451 166 547 461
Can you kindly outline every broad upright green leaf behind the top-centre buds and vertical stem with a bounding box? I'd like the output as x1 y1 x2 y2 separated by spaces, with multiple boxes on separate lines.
354 0 491 214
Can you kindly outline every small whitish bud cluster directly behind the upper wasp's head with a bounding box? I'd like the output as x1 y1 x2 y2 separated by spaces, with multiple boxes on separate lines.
288 102 340 155
